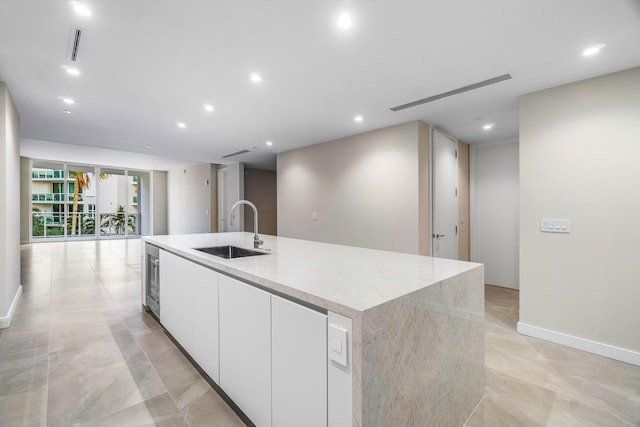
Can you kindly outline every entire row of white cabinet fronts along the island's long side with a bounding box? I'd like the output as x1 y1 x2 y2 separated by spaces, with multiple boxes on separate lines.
160 250 342 427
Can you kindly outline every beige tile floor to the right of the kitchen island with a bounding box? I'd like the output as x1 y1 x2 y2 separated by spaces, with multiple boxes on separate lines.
466 286 640 427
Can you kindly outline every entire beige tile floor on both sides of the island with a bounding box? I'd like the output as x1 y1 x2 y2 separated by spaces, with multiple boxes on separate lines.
0 240 640 427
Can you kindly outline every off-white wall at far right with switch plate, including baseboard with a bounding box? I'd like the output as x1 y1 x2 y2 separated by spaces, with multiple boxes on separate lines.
518 68 640 365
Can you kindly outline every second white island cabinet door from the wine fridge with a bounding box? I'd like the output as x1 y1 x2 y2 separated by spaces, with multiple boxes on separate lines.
191 264 220 384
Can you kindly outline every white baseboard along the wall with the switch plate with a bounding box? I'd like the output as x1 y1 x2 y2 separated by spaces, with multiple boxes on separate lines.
518 322 640 366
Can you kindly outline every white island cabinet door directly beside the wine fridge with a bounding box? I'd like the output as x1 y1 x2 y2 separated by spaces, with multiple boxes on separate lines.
160 250 193 352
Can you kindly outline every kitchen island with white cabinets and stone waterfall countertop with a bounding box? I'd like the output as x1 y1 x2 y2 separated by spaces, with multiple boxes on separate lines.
143 233 485 427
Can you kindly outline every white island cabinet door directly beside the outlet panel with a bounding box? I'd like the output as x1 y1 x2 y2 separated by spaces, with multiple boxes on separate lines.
271 296 327 427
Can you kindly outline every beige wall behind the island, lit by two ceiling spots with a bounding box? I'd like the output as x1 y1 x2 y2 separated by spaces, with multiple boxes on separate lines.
277 122 428 254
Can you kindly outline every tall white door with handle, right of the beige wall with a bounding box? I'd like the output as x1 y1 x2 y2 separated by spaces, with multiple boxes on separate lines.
431 129 458 259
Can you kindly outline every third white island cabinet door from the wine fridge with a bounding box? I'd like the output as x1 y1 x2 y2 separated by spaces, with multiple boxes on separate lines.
219 275 271 427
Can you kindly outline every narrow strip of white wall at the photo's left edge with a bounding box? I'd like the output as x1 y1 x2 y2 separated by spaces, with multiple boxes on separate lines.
0 82 22 328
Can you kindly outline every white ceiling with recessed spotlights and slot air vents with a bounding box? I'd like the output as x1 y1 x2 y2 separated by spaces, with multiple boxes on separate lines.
0 0 640 168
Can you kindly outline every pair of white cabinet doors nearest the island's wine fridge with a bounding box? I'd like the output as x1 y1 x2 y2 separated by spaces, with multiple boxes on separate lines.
160 250 220 383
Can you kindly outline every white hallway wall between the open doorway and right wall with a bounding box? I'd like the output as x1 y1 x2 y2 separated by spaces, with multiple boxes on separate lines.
470 140 520 288
